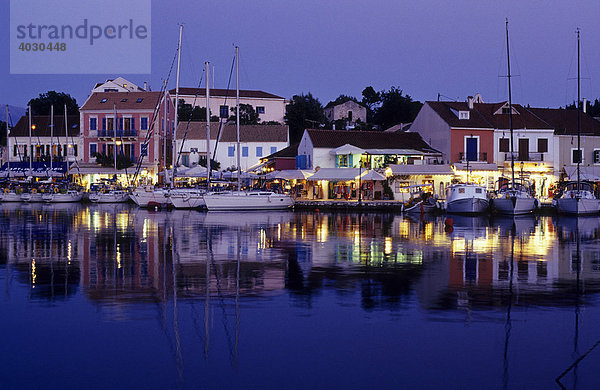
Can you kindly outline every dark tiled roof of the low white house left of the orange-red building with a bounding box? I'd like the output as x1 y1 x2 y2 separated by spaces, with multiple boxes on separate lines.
306 129 439 153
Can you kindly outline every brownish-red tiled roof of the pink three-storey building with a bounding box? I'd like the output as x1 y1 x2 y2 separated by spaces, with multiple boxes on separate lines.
79 91 163 111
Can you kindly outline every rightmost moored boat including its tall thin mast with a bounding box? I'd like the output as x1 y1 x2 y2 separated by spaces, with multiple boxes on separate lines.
556 30 600 215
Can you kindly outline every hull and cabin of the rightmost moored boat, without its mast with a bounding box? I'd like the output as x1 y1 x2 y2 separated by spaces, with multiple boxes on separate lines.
556 181 600 215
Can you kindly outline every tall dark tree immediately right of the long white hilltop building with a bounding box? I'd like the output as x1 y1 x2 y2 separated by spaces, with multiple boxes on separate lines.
285 92 327 144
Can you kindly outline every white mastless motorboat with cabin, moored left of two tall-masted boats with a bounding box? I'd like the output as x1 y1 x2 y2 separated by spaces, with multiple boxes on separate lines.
446 183 489 214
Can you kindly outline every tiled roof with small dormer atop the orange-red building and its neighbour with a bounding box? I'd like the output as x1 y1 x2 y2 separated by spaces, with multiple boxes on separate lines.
425 102 552 130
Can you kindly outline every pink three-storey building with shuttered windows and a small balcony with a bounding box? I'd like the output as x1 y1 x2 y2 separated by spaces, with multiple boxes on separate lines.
79 92 175 181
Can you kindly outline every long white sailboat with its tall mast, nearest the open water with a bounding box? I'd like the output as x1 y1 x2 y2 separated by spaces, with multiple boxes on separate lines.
204 46 294 211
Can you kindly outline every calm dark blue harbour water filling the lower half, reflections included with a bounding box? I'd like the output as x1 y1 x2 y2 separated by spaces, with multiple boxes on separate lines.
0 204 600 389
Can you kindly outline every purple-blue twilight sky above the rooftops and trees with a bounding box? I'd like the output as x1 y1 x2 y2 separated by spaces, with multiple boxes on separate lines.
0 0 600 111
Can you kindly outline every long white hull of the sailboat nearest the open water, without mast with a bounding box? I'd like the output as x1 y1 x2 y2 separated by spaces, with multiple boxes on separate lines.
204 192 294 211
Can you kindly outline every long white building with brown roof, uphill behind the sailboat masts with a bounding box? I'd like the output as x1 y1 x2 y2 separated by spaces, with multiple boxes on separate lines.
169 88 288 124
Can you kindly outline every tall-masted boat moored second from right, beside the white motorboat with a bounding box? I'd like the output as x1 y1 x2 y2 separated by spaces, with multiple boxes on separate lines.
492 20 538 215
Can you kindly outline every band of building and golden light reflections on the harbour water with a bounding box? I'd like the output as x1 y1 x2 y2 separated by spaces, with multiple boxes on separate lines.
0 204 600 310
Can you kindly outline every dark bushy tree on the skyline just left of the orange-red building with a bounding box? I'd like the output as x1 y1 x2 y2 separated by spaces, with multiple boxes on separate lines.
373 87 423 129
